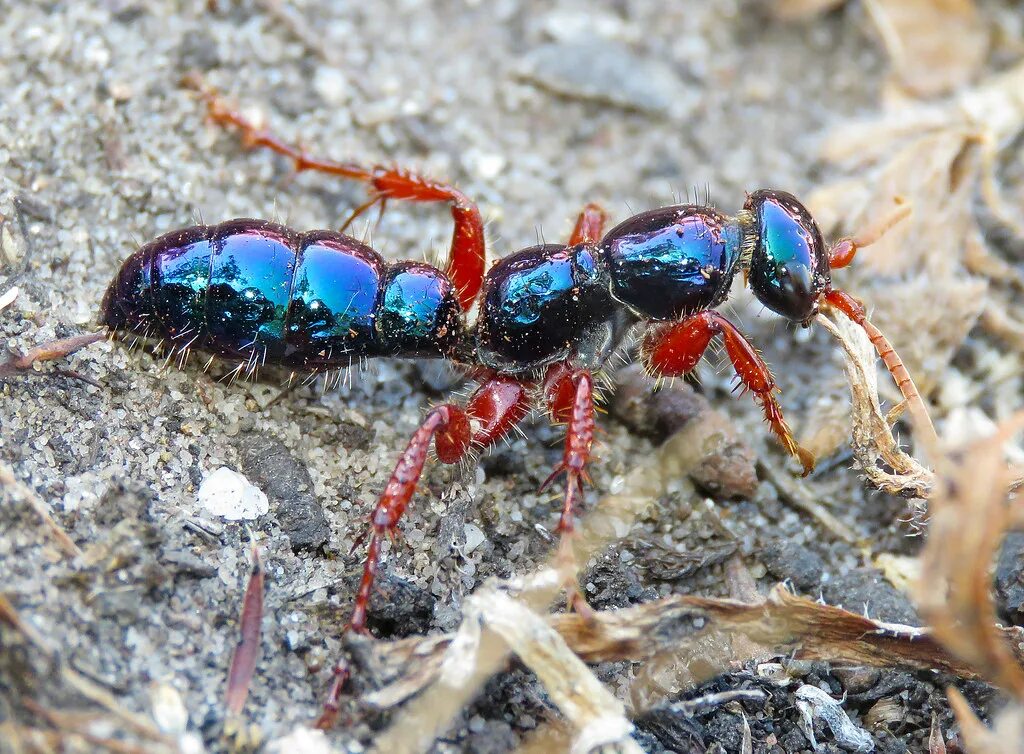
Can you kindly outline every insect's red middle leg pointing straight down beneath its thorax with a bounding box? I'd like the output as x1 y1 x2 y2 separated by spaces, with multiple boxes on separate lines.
541 364 594 615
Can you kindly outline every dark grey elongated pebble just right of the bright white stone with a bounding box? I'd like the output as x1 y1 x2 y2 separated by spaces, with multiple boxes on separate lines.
238 434 331 550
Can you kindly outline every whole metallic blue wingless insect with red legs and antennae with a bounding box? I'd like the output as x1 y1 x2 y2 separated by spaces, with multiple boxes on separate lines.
12 80 933 721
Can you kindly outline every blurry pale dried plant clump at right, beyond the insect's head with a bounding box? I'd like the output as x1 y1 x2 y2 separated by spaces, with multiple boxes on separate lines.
808 64 1024 465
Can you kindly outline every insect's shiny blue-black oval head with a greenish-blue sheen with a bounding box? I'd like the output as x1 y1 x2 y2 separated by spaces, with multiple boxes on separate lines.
745 191 828 322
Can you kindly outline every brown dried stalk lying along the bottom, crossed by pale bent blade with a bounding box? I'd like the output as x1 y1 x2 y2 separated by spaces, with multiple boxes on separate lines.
362 572 1024 727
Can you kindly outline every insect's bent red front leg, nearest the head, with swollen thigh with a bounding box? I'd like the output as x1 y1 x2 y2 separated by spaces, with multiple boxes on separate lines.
643 311 814 476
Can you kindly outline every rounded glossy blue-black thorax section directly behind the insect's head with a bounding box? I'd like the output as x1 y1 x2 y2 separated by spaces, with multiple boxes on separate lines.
600 205 739 320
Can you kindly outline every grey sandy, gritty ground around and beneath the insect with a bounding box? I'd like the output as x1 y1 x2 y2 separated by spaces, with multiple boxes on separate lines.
0 0 1024 752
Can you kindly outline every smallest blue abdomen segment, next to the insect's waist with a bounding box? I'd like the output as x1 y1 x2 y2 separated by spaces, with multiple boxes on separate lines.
376 262 461 355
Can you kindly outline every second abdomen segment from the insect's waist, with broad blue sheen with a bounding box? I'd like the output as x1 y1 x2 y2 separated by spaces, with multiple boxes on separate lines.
286 231 385 367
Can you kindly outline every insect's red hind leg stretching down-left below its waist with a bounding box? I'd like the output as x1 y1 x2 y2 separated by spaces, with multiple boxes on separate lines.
316 375 529 728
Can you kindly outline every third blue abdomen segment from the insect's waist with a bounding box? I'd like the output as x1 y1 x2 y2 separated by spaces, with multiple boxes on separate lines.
206 220 296 360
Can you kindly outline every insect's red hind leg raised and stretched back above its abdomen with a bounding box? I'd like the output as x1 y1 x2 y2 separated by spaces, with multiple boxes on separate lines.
185 76 485 311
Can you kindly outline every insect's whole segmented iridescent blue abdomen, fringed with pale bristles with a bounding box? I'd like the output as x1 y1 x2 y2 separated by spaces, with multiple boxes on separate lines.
100 219 462 370
